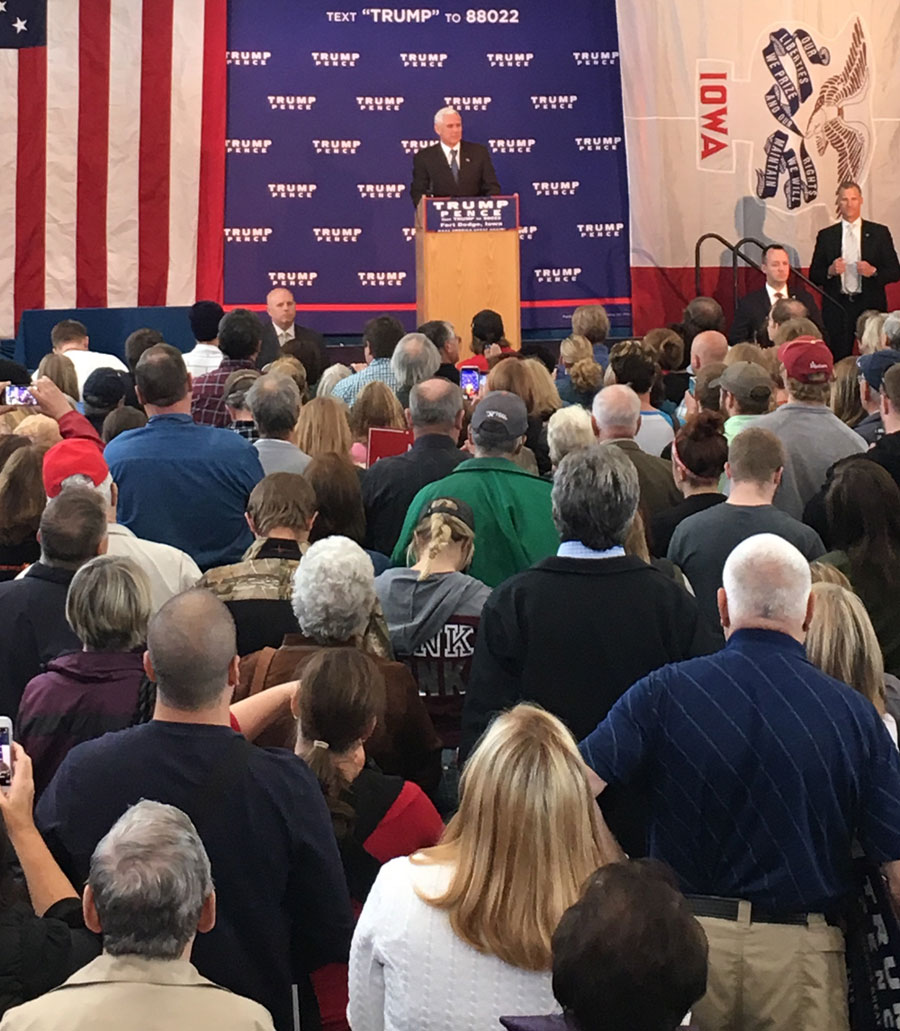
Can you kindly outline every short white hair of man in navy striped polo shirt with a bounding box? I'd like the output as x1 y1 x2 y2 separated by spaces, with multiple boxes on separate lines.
722 533 811 626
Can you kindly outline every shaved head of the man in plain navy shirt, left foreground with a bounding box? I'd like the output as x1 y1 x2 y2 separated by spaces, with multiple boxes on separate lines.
146 591 237 712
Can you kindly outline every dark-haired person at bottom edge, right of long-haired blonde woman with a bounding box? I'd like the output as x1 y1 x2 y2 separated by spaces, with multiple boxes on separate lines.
500 859 709 1031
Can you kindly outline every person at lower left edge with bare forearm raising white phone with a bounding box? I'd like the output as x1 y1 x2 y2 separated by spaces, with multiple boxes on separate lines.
0 738 100 1015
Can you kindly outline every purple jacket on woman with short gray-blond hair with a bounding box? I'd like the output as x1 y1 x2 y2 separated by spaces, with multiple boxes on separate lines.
15 652 143 798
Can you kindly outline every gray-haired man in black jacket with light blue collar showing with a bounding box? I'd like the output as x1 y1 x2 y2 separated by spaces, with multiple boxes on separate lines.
460 444 721 855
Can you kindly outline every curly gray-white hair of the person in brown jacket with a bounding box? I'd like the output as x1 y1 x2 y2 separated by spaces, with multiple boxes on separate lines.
292 536 375 644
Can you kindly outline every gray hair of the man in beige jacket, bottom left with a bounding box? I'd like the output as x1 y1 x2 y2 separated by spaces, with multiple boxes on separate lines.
88 800 212 960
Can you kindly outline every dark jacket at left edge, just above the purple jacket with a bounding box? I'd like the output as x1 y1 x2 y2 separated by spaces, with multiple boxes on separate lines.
0 562 81 718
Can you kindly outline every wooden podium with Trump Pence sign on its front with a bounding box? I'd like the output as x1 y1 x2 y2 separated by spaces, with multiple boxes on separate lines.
415 194 522 358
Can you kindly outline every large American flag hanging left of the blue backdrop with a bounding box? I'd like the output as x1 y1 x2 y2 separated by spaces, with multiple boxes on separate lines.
0 0 227 337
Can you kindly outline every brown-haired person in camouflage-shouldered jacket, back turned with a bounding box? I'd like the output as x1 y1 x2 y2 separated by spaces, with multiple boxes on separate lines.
197 472 316 655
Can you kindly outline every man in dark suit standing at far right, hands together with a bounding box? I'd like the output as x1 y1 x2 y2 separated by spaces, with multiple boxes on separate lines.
809 182 900 359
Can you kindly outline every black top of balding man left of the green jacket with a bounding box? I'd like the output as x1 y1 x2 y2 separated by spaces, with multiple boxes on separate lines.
363 433 471 555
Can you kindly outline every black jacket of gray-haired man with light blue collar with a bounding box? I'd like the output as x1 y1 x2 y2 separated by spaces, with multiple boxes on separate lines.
460 556 722 855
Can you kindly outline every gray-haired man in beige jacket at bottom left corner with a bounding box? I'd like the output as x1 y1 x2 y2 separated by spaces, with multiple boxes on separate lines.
2 801 272 1031
